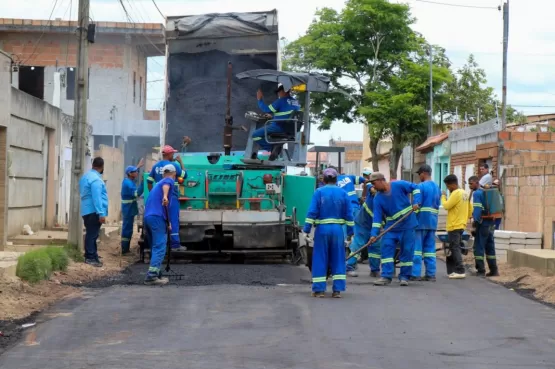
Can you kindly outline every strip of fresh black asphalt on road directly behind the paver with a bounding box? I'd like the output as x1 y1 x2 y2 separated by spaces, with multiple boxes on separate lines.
71 264 310 288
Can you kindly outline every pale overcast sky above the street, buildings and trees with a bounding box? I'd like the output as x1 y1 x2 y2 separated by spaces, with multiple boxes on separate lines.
4 0 555 144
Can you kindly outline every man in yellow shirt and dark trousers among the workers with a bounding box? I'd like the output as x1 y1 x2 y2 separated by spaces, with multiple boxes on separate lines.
441 174 469 279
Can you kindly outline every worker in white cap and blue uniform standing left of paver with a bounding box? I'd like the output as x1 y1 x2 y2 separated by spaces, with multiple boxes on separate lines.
144 164 179 285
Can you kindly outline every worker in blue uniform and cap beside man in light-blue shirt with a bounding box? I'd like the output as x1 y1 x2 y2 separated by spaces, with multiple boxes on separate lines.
121 159 144 254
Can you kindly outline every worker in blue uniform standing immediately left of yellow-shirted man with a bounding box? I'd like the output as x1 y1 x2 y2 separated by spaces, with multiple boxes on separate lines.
411 164 441 282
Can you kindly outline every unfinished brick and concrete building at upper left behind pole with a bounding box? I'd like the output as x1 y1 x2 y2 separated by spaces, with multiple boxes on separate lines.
0 18 164 165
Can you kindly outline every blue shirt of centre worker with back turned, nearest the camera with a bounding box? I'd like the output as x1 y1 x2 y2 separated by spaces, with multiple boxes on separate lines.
303 184 355 236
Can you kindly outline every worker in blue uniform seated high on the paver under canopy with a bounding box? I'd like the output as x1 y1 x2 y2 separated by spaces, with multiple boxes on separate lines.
252 83 301 160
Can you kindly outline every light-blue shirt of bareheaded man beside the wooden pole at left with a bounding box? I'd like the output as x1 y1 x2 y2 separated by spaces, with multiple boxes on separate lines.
79 169 108 217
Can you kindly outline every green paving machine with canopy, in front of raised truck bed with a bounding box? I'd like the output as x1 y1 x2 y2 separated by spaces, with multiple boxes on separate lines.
139 69 330 263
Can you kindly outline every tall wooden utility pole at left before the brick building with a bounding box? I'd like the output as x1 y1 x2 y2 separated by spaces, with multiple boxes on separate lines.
68 0 90 250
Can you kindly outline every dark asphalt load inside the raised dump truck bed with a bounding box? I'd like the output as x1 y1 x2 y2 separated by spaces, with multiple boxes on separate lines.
166 50 277 152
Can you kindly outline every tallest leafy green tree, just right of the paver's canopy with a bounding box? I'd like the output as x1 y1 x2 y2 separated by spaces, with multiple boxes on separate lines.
284 0 417 171
